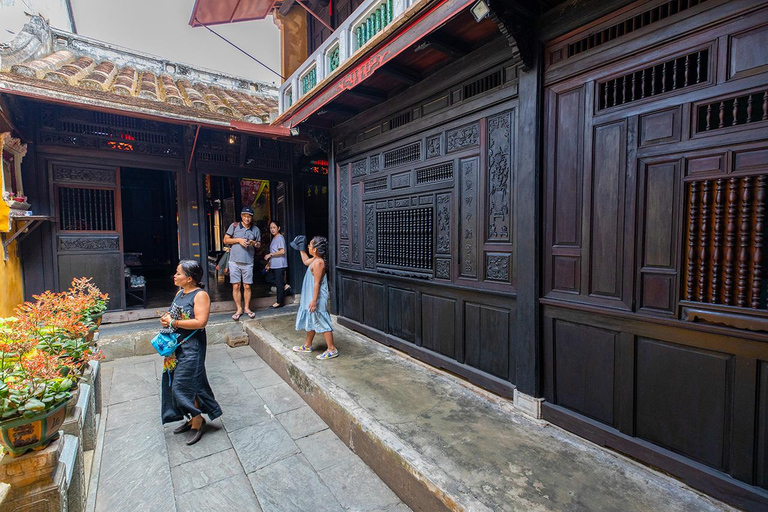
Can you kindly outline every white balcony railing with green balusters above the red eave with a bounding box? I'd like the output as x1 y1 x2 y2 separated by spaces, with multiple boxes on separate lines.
279 0 420 114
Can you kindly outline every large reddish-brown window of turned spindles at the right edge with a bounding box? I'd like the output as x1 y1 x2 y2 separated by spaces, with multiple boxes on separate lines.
684 174 768 309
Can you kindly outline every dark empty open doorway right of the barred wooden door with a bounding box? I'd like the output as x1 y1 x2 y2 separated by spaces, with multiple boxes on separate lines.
120 168 179 309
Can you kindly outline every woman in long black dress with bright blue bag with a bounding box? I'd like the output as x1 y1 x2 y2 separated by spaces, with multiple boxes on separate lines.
160 260 221 444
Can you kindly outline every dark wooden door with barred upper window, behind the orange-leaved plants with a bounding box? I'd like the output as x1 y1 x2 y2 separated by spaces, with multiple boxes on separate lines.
49 162 125 309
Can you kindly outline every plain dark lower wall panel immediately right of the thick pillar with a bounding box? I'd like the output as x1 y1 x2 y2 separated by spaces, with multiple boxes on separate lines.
553 320 617 425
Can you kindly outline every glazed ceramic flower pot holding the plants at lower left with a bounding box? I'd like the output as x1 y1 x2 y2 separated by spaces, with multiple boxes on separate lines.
0 402 67 457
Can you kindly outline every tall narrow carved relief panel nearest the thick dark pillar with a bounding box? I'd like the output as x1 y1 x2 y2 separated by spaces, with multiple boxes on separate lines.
488 112 512 241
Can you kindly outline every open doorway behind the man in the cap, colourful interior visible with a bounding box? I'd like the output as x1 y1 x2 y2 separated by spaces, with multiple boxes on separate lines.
203 175 285 301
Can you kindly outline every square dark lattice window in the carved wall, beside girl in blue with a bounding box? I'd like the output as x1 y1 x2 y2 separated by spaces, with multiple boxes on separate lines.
376 208 434 271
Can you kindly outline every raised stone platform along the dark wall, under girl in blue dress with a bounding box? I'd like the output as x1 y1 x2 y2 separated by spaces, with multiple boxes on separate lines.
246 315 732 512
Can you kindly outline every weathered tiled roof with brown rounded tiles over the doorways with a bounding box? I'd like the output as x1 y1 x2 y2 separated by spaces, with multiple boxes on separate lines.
0 18 277 124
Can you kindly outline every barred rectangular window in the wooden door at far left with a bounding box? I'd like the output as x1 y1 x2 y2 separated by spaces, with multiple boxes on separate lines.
58 187 115 231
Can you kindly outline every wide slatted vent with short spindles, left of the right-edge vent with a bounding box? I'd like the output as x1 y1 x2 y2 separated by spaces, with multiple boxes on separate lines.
597 48 709 110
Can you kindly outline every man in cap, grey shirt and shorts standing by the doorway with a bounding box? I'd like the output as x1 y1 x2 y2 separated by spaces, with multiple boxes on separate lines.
224 206 261 320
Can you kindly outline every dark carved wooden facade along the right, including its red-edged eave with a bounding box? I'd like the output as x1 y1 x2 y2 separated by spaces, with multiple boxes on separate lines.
278 0 768 510
